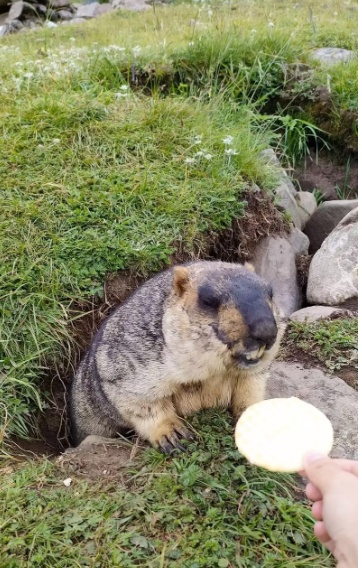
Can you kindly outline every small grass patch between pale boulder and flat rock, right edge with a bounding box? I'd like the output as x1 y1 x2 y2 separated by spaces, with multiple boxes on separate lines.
283 318 358 373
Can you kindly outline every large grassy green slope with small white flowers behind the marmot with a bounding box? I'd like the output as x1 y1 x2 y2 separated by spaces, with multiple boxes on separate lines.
0 0 357 441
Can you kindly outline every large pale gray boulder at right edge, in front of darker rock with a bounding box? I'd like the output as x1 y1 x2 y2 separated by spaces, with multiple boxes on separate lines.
307 208 358 306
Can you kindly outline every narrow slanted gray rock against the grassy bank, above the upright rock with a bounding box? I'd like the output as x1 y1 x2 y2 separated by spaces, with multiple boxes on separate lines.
260 148 302 229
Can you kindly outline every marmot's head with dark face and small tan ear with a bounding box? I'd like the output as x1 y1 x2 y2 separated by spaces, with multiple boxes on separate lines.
173 261 284 369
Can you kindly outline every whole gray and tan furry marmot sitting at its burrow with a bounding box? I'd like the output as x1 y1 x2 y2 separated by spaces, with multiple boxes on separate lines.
70 261 285 452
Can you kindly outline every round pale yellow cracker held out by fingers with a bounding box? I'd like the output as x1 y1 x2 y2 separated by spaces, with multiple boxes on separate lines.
235 397 333 473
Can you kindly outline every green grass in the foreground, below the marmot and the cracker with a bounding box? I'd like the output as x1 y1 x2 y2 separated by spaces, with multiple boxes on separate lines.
0 411 334 568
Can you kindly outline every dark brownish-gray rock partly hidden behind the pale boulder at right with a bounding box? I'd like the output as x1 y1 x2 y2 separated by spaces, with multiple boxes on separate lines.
304 199 358 254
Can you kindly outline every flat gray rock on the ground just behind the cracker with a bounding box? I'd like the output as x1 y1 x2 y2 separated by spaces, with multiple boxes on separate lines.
267 361 358 459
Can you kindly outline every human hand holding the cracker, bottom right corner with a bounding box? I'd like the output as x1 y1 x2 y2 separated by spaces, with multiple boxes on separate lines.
300 454 358 568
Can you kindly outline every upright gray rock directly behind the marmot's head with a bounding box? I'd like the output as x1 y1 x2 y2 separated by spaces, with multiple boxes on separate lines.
253 237 302 317
